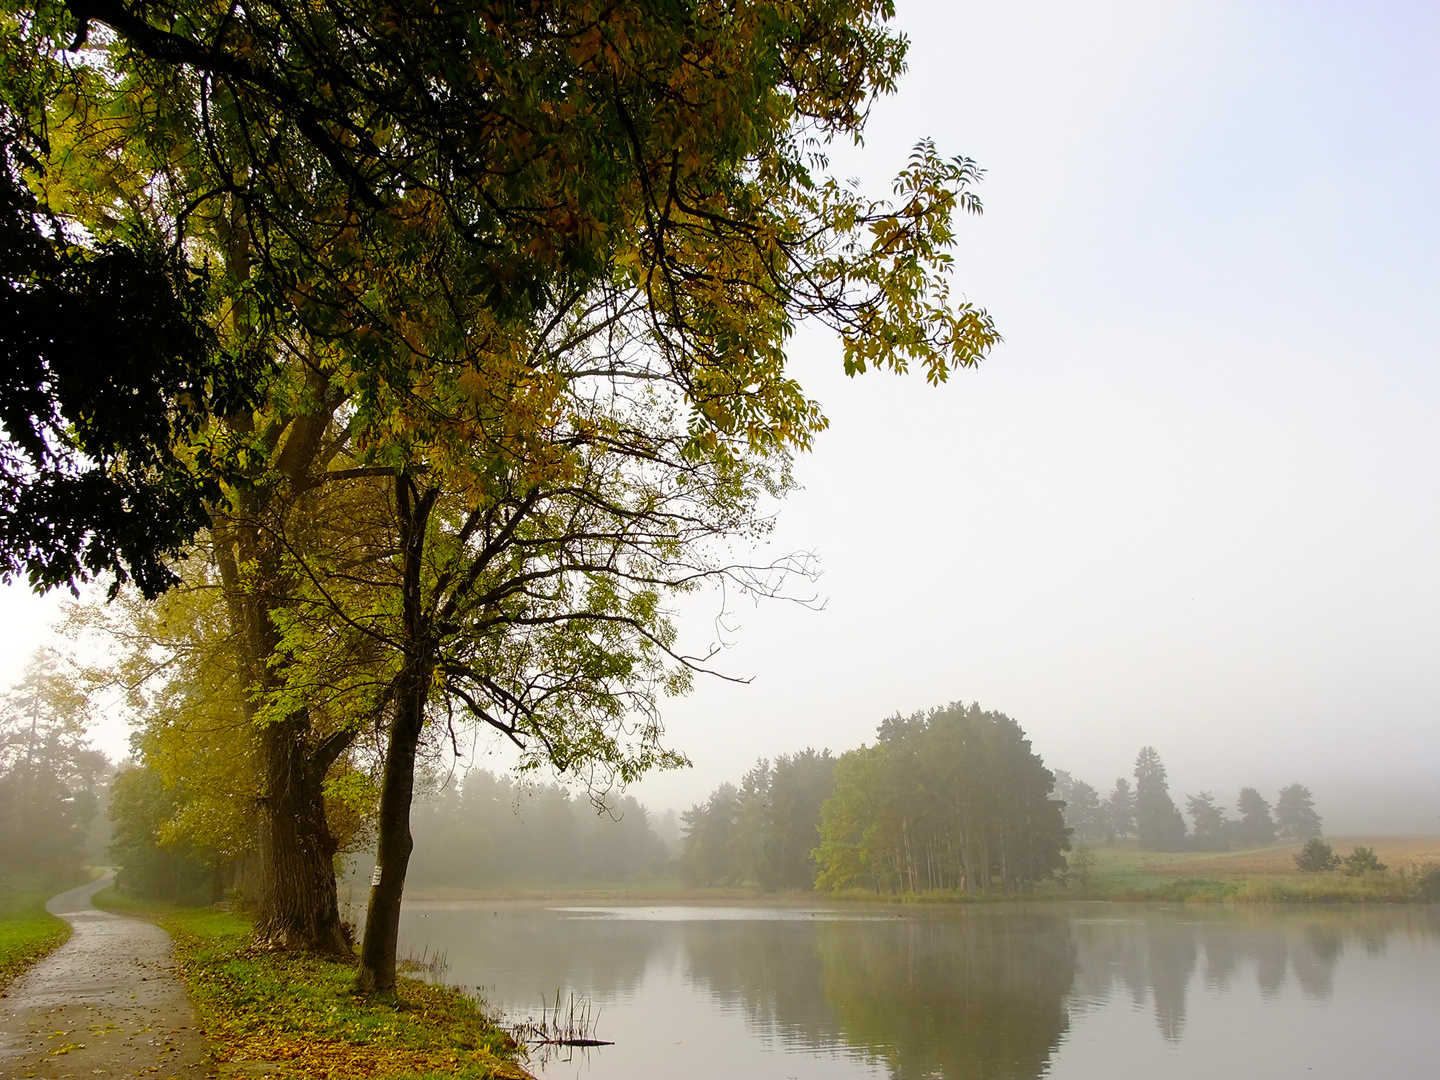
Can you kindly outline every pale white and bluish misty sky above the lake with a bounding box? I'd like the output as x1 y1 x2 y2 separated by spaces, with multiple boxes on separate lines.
0 0 1440 831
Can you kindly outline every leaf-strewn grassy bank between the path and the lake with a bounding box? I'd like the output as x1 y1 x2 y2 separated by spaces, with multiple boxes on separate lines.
95 890 528 1080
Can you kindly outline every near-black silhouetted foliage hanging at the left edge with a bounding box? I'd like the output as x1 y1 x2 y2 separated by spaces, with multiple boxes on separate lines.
0 106 264 596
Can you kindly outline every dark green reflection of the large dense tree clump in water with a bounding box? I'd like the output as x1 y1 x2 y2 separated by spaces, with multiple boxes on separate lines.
685 909 1074 1080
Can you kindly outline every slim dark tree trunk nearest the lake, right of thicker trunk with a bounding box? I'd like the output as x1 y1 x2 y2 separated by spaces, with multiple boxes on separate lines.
356 475 439 995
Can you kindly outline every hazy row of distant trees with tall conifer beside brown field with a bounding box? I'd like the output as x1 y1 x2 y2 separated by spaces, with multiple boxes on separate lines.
1056 746 1320 851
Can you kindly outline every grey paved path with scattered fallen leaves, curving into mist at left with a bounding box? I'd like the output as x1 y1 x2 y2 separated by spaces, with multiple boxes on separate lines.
0 874 209 1080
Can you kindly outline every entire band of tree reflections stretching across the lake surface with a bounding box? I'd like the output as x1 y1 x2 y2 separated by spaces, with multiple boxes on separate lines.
408 904 1440 1080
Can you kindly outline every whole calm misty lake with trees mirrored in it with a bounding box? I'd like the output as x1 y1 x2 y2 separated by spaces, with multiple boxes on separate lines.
402 900 1440 1080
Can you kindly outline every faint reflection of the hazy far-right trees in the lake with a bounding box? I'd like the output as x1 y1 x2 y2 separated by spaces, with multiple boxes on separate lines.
1071 906 1440 1043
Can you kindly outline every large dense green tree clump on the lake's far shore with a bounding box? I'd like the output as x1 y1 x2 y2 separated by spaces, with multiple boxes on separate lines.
683 703 1068 893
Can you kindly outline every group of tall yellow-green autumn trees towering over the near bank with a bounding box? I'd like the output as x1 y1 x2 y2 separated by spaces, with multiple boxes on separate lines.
0 0 996 991
